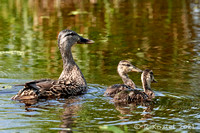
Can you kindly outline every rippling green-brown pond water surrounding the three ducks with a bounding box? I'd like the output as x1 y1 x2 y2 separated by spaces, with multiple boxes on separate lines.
0 0 200 133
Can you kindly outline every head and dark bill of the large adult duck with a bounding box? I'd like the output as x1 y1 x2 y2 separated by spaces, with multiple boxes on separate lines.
58 29 94 48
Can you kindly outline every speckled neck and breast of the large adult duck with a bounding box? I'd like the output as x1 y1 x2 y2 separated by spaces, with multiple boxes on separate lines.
59 42 87 86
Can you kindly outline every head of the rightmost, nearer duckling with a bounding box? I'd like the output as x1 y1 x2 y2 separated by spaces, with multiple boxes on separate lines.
141 69 157 85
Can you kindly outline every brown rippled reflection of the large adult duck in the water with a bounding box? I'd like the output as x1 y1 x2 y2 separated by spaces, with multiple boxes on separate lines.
25 96 82 133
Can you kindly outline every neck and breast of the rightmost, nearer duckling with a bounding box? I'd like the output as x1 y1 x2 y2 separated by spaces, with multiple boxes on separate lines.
142 77 155 98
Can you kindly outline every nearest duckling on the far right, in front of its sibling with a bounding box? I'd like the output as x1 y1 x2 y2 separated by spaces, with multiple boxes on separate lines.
113 69 157 103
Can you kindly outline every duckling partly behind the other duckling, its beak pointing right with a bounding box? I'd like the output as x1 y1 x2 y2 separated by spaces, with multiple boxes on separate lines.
104 60 142 97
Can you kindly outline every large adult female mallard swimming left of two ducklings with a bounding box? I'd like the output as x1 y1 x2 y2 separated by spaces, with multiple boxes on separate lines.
12 29 94 100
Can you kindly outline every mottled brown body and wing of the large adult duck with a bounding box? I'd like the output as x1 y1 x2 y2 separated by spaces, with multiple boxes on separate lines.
12 79 87 100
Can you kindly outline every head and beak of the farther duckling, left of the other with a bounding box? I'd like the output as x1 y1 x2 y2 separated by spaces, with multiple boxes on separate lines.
117 60 142 74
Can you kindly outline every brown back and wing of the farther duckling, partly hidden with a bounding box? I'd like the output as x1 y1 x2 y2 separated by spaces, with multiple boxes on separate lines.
104 84 130 97
